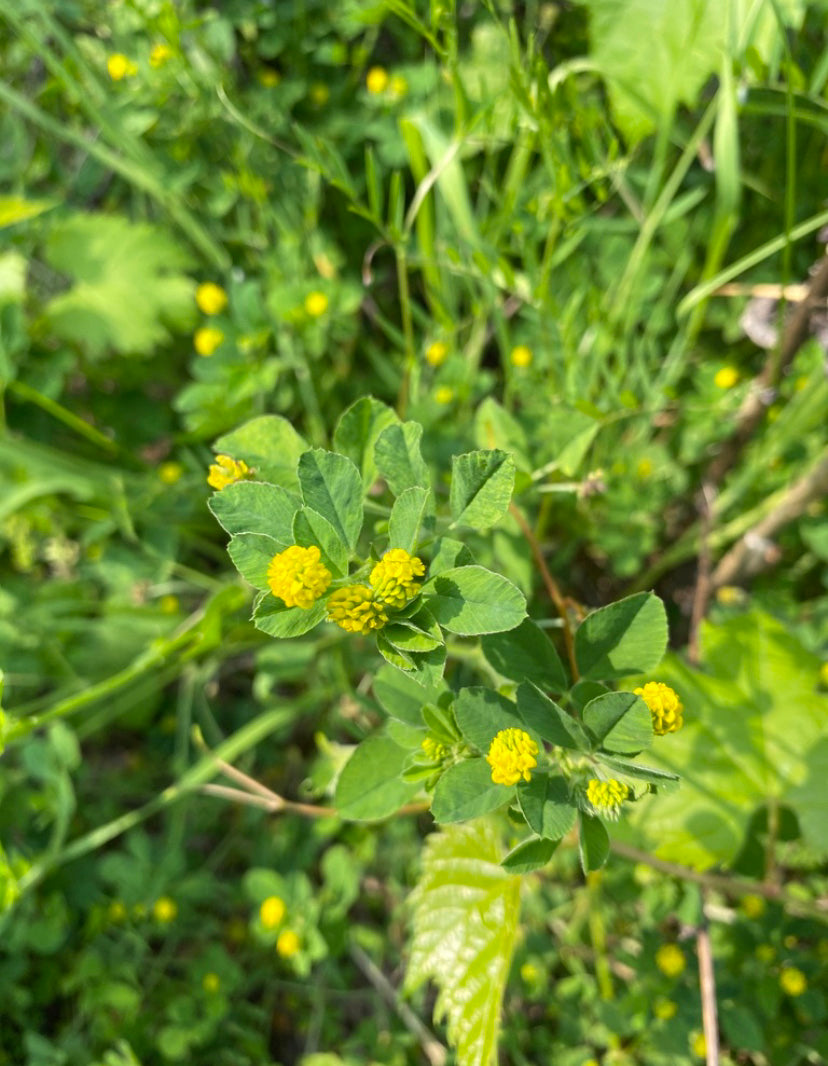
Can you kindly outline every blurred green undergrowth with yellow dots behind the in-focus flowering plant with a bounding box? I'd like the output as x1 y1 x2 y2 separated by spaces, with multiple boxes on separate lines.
0 0 828 1066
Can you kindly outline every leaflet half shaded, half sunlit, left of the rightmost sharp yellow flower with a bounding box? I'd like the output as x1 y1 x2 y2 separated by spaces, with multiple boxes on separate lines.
575 593 667 681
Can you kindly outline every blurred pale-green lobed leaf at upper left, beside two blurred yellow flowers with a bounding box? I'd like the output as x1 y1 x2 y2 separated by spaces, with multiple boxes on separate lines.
45 214 196 357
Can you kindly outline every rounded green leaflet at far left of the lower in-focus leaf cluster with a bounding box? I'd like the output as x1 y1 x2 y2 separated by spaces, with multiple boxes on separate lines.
334 734 419 822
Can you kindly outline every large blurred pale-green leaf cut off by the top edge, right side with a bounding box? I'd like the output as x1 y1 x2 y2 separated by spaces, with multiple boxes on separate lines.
583 0 729 142
